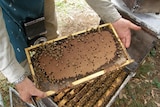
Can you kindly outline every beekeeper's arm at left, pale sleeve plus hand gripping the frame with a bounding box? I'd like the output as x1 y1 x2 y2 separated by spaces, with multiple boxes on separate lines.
0 8 45 102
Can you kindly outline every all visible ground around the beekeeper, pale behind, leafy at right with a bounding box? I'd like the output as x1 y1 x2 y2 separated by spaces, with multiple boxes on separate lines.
0 0 160 107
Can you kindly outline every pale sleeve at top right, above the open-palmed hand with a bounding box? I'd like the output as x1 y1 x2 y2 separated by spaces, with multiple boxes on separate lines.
86 0 121 23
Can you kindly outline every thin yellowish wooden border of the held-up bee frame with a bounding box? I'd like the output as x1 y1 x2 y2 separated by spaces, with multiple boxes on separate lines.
25 23 133 96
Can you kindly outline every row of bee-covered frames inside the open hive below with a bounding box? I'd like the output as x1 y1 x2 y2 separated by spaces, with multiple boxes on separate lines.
51 70 128 107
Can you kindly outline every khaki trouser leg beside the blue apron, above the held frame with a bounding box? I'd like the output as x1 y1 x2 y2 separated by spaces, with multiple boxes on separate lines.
44 0 58 40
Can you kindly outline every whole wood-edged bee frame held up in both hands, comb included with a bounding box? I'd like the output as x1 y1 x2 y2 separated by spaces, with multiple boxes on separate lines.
25 24 133 93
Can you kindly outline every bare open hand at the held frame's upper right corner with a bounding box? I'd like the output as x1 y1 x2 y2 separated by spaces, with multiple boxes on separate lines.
112 18 141 48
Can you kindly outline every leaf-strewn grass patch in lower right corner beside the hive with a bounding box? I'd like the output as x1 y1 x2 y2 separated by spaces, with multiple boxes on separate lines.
112 50 160 107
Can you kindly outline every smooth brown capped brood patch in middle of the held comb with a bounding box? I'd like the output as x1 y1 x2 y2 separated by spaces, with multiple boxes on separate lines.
38 31 116 80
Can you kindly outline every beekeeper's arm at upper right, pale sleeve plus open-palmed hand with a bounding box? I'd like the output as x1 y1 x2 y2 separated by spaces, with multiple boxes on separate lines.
86 0 141 48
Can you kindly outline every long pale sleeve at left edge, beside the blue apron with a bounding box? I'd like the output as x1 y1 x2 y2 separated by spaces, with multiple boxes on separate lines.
0 8 25 83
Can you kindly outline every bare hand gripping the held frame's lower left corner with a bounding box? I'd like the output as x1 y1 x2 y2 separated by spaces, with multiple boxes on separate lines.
16 78 46 103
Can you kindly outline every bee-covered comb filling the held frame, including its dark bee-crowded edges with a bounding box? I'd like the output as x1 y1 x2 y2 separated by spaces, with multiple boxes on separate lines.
30 29 123 91
